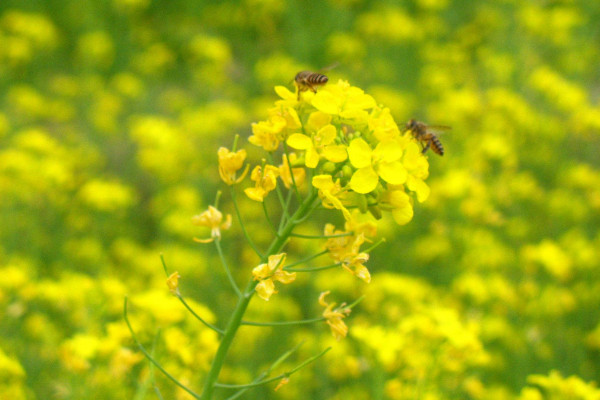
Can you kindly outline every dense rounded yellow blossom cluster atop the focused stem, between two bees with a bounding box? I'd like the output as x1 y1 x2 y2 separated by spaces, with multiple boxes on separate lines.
244 80 429 224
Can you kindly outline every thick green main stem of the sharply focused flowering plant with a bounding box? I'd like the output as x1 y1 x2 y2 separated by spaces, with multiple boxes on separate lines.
200 190 317 400
